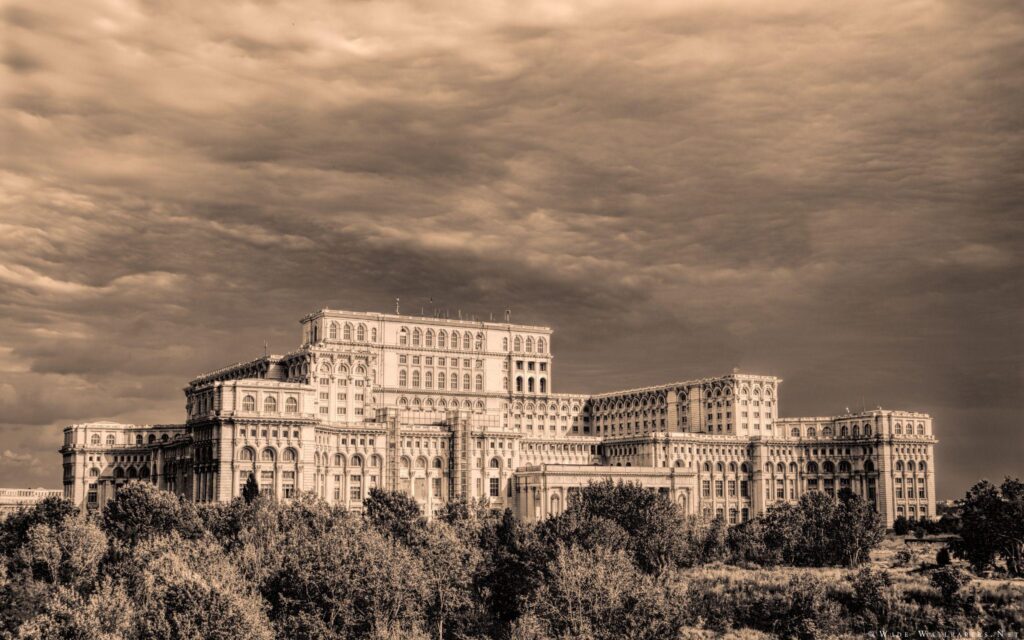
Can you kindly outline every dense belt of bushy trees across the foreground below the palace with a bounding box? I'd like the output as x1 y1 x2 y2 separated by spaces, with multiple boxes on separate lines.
0 481 1014 640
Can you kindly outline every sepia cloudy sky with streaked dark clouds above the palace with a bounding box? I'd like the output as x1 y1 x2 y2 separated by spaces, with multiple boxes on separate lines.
0 0 1024 499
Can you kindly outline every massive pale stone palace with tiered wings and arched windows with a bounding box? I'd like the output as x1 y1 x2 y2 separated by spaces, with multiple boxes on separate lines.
60 309 936 526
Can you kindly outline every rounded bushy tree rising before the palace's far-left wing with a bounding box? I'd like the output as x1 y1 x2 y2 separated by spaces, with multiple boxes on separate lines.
103 481 204 545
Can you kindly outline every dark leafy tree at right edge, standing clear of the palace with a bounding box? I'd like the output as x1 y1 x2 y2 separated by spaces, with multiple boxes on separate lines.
951 478 1024 577
